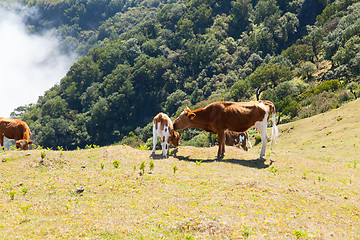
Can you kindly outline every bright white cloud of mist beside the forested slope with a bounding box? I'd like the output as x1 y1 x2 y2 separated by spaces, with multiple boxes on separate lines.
0 2 74 117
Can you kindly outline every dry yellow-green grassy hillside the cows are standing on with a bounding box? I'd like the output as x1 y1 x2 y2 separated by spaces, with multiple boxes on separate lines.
0 100 360 239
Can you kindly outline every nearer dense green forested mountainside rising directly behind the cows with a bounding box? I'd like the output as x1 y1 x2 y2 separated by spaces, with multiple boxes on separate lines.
10 0 360 149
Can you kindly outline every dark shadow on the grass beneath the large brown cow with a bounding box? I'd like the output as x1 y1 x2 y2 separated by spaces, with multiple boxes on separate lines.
170 148 274 169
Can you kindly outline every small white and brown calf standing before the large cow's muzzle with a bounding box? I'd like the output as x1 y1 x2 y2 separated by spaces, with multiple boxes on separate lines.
152 113 180 158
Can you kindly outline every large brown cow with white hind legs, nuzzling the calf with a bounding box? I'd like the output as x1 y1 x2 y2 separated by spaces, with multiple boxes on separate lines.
174 101 278 158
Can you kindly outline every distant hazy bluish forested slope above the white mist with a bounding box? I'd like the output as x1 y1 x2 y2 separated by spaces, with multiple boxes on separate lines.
13 0 180 57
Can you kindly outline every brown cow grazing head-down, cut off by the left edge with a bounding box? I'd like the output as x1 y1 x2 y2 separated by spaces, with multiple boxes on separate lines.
0 118 33 150
